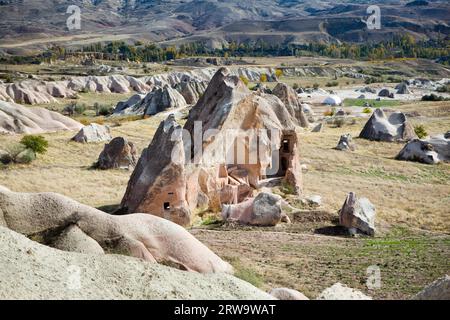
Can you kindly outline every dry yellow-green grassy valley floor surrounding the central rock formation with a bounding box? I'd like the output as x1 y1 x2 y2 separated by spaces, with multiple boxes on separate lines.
0 75 450 299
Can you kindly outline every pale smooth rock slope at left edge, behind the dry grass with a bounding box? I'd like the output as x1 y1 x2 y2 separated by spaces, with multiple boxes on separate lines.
0 101 83 134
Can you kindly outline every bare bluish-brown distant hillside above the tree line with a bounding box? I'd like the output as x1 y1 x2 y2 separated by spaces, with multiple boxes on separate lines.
0 0 450 53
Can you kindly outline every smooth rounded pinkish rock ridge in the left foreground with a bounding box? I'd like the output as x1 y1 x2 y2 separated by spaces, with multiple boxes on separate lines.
0 187 232 273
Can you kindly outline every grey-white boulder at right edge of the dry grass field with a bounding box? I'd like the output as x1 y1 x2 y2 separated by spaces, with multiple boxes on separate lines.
396 135 450 164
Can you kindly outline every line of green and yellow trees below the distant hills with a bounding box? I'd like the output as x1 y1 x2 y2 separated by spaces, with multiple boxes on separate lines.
0 35 450 65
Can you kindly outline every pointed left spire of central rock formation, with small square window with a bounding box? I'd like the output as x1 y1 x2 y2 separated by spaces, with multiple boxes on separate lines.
121 116 191 225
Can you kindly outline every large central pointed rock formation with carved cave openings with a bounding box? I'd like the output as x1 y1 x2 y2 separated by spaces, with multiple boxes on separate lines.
121 68 304 225
